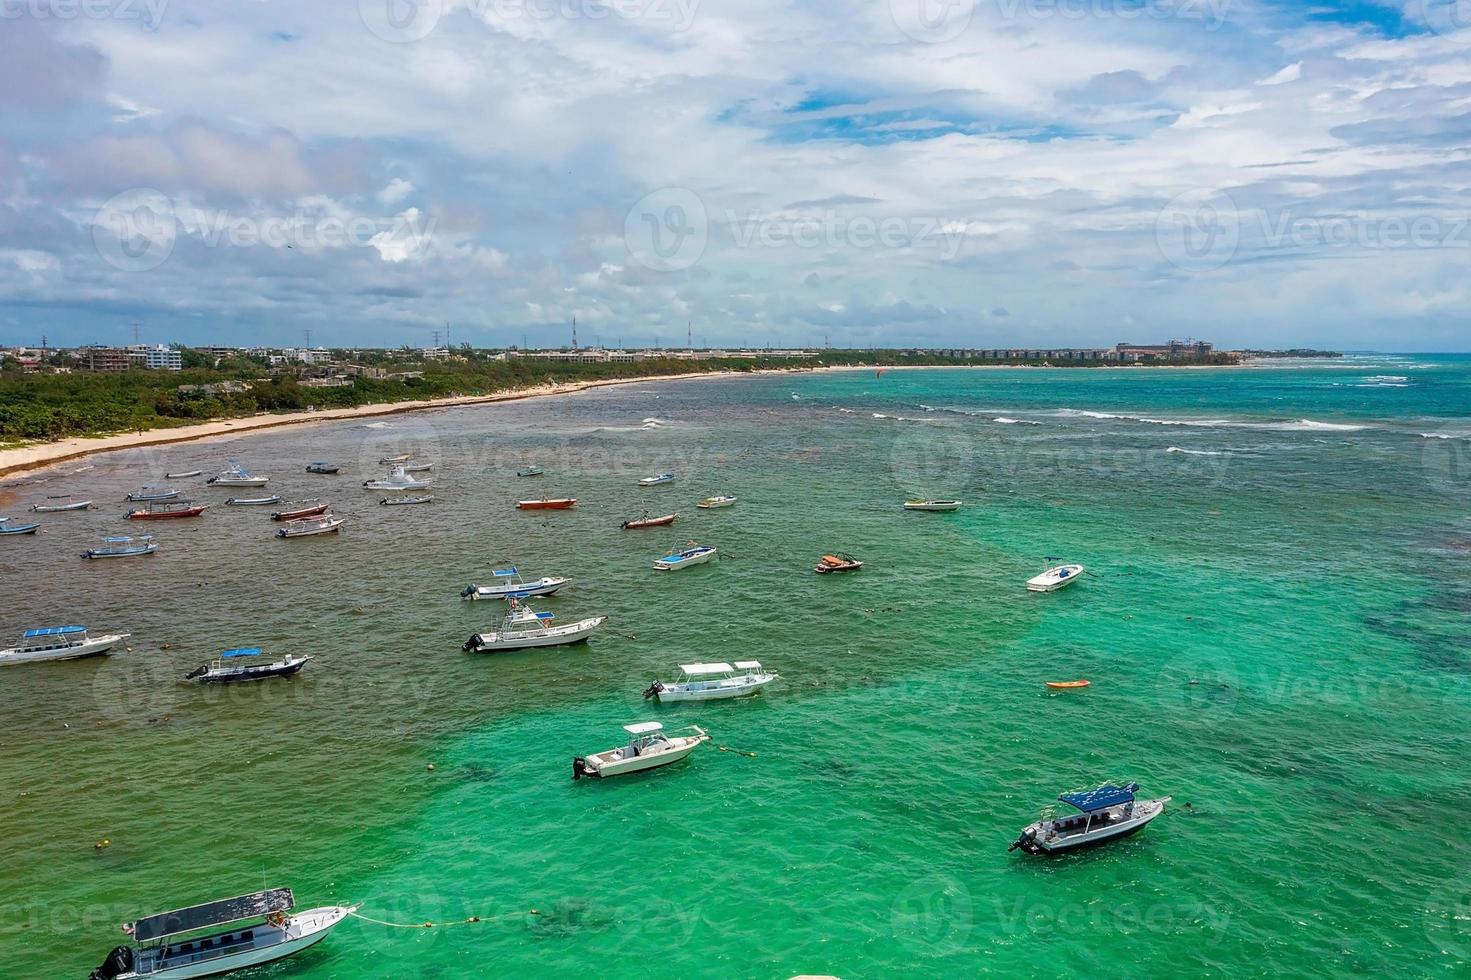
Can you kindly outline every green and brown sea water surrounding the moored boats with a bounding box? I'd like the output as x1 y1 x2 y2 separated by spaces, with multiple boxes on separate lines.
0 355 1471 980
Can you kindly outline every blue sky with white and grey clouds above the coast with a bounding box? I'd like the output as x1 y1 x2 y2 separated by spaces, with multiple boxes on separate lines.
0 0 1471 350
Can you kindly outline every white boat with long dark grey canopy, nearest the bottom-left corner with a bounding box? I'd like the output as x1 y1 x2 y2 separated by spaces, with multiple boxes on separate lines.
90 889 357 980
